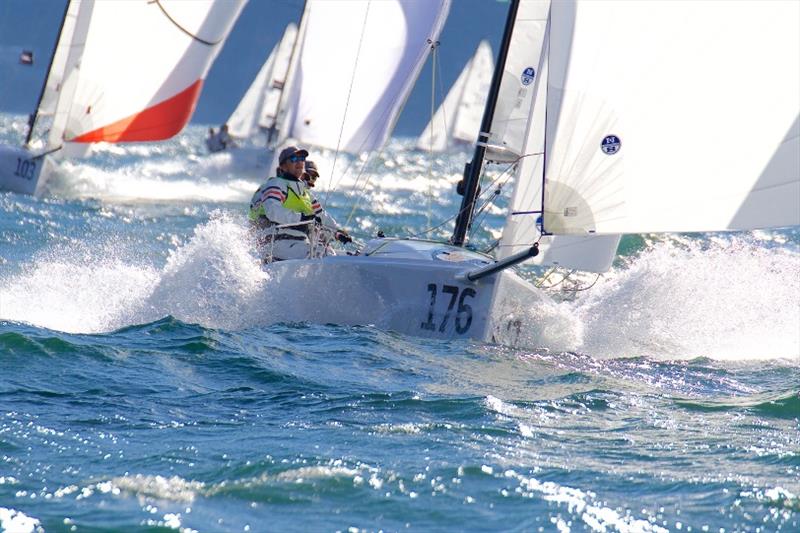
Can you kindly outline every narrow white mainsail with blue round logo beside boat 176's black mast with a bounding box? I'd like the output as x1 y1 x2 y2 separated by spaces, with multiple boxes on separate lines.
486 0 550 161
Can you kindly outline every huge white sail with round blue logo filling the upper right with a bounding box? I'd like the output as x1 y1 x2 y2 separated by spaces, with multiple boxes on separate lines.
544 1 800 234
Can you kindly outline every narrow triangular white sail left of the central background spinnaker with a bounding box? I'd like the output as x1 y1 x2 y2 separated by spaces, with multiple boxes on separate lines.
227 23 297 138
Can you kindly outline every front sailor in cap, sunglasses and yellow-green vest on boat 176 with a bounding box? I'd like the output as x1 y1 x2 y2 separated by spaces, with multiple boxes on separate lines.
249 146 352 262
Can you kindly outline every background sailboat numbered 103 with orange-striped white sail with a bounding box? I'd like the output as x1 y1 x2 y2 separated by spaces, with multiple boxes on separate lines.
0 0 245 194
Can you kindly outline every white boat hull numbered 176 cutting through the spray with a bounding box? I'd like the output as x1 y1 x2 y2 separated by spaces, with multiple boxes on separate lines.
264 239 548 344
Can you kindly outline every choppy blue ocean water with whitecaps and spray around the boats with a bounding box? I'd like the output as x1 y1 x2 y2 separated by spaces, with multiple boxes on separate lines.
0 115 800 533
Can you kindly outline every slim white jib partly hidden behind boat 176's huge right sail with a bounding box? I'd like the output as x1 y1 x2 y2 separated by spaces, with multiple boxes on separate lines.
496 37 620 272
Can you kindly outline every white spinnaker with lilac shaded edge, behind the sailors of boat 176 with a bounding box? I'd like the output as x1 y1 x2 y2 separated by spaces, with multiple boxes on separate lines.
281 0 450 153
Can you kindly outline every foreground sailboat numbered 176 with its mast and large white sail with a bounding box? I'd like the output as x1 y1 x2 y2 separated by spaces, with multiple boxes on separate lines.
266 0 800 342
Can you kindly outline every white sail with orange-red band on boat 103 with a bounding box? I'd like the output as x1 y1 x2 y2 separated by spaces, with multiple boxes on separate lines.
51 0 244 147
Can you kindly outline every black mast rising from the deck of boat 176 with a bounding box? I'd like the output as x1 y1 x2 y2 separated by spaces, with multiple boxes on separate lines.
450 0 519 246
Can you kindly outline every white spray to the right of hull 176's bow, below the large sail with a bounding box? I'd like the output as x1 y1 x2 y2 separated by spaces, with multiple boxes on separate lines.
574 236 800 359
